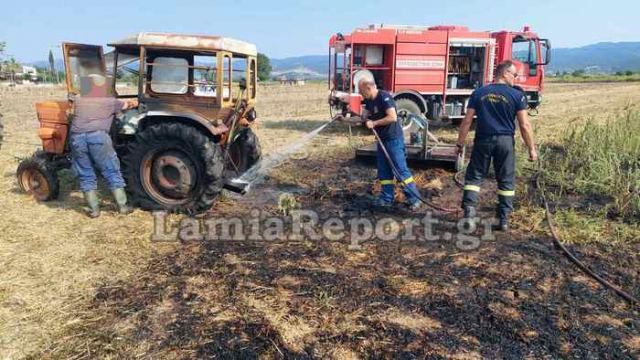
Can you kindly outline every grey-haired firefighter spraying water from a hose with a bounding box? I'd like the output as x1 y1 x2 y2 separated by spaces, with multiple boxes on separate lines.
339 78 422 211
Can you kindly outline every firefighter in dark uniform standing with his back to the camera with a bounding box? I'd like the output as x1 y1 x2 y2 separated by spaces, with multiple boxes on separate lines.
457 60 538 231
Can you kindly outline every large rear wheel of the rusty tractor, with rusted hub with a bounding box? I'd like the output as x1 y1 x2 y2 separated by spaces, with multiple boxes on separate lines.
123 123 224 214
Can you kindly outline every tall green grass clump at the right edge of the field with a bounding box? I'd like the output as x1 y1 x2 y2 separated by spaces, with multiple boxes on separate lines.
541 111 640 221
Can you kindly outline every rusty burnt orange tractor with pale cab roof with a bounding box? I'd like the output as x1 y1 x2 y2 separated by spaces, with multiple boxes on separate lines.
17 33 261 213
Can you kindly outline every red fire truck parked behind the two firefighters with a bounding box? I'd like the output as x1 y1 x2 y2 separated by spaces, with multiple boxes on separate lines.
329 25 551 129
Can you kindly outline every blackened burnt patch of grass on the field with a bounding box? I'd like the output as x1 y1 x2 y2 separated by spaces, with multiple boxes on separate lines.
49 154 640 359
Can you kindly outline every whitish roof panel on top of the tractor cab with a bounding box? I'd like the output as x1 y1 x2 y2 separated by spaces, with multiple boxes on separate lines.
108 32 258 56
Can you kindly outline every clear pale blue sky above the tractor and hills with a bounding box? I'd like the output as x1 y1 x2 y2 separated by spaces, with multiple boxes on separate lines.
0 0 640 62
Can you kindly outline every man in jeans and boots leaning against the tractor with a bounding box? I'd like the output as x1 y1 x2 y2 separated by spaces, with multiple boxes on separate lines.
70 75 138 218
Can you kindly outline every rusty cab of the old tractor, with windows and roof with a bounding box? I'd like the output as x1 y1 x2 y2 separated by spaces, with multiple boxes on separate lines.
63 33 257 143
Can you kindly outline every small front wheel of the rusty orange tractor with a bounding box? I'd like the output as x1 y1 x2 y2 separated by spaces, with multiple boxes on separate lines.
16 151 60 201
